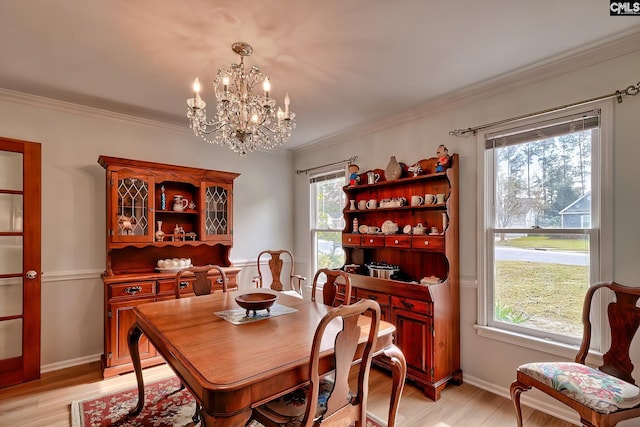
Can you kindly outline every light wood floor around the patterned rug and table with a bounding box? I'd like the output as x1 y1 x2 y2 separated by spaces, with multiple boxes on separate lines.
0 362 573 427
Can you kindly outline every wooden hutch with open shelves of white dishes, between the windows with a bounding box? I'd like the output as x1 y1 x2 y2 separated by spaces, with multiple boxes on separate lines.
342 154 462 400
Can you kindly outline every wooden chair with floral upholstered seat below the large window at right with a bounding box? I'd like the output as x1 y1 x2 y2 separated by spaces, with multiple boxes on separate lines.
510 282 640 427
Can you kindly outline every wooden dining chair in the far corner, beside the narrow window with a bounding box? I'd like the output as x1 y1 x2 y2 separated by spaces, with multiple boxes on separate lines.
253 249 307 298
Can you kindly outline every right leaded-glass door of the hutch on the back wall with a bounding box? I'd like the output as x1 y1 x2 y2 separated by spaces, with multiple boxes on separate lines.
200 182 233 242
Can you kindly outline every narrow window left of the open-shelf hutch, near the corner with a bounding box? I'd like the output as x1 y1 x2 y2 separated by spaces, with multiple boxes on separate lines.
309 169 346 274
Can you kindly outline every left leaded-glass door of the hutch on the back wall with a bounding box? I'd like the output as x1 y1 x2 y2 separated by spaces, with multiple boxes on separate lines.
110 171 153 242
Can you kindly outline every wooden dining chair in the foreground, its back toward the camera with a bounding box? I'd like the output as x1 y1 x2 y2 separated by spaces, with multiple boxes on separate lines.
252 300 388 427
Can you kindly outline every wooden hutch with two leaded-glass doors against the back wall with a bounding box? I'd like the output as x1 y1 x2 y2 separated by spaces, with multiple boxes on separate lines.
98 156 240 377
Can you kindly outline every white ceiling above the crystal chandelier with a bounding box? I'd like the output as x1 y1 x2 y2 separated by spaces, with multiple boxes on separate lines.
0 0 640 148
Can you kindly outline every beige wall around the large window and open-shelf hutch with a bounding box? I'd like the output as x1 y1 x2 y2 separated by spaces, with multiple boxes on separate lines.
294 50 640 421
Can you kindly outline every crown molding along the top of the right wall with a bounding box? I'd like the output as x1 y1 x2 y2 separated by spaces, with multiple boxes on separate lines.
292 25 640 154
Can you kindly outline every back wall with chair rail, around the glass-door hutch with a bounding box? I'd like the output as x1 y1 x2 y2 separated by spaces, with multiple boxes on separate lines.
0 90 294 371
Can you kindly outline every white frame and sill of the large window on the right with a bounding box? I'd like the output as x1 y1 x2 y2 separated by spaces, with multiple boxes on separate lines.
475 100 613 359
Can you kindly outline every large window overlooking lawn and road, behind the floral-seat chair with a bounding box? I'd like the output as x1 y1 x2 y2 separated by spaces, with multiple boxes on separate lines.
478 103 612 350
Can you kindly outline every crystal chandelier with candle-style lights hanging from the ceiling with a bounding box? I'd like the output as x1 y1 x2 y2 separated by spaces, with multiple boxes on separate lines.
187 42 296 156
